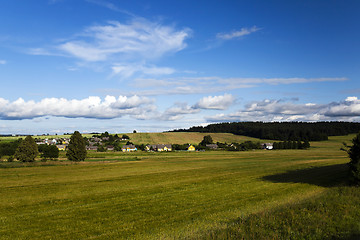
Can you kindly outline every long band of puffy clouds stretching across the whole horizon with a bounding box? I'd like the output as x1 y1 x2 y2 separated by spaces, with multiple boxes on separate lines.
0 94 360 122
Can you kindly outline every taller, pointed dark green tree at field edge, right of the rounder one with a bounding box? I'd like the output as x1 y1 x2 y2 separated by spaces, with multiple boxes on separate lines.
66 131 86 162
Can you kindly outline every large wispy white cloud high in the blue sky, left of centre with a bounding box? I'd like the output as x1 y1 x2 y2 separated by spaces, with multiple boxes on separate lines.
58 18 191 61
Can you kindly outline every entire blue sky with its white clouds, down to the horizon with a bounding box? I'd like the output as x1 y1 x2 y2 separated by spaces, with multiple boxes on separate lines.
0 0 360 134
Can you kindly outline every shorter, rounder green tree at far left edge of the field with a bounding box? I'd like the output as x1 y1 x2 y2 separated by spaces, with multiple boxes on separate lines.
14 136 39 162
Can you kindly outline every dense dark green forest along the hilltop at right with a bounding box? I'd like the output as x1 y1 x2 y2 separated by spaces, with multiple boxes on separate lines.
174 122 360 141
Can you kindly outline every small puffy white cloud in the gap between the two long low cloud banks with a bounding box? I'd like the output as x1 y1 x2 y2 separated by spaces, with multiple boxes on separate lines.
195 94 235 110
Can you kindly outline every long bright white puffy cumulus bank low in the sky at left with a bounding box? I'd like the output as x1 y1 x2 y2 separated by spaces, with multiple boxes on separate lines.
0 96 154 120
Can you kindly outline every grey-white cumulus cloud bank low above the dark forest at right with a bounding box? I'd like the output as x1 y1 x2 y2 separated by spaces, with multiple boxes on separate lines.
207 97 360 122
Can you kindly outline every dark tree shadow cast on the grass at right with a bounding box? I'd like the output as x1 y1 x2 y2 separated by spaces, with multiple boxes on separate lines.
262 164 348 187
